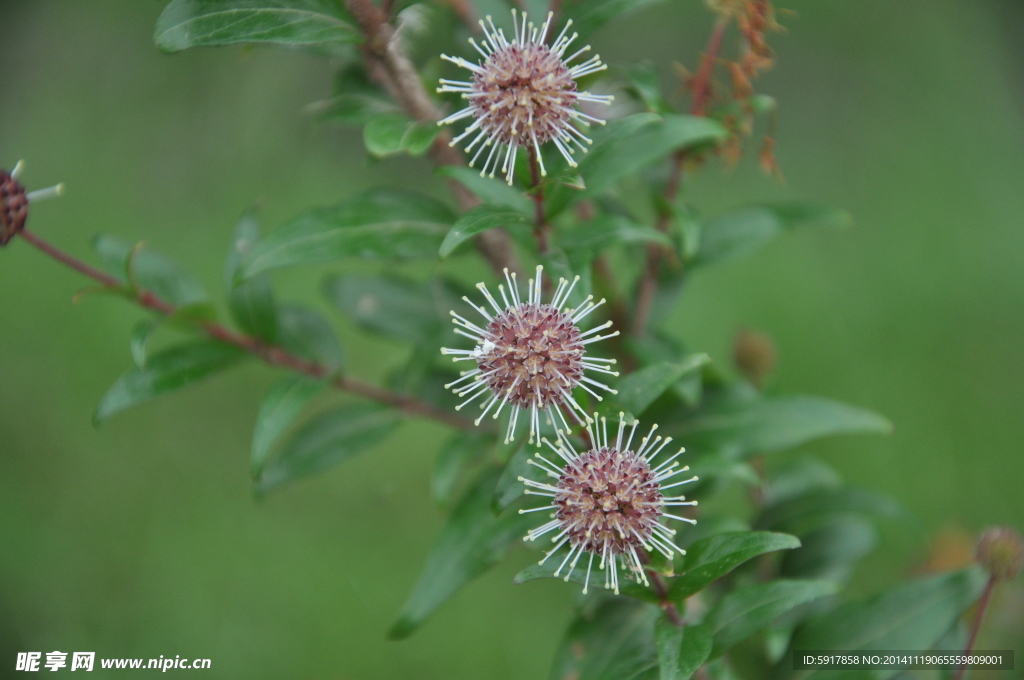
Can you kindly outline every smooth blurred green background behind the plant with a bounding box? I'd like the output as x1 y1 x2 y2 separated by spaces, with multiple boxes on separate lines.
0 0 1024 680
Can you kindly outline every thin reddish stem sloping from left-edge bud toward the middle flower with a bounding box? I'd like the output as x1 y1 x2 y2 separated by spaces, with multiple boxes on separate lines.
19 229 473 430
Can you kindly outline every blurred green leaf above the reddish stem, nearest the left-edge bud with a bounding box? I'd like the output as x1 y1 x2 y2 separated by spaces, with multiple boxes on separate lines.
92 233 207 307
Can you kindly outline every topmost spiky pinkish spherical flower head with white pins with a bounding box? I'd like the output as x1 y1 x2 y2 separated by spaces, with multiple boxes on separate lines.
437 9 612 184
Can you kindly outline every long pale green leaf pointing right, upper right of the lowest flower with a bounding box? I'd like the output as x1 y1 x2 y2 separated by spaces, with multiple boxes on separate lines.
666 395 892 456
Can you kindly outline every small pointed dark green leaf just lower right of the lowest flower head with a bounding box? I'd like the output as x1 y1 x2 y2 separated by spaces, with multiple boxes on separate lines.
669 532 800 602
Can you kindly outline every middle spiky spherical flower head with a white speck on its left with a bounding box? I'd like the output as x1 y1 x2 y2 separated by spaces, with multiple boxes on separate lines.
441 266 618 442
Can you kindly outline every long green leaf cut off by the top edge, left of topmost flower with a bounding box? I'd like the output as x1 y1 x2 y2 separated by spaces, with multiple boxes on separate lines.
154 0 358 52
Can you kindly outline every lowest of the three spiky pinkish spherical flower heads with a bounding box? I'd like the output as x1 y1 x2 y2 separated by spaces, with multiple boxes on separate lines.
519 414 697 594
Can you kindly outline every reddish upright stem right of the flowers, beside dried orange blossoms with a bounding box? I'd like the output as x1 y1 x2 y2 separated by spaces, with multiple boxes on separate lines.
632 16 729 338
